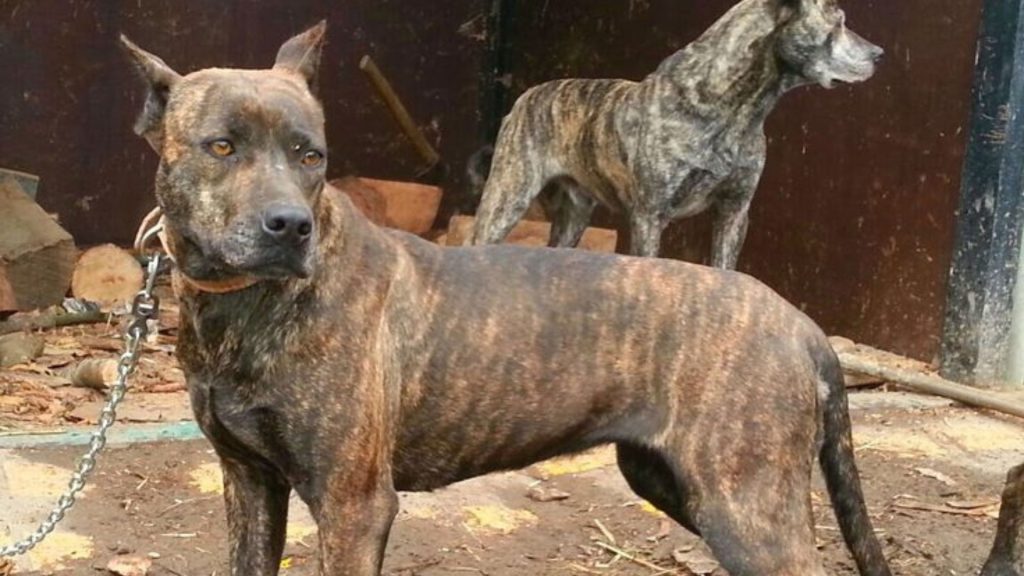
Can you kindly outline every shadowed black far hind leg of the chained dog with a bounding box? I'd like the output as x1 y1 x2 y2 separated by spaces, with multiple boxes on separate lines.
615 443 700 536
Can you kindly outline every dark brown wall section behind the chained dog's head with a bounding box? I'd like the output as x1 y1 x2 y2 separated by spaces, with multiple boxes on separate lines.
0 0 487 244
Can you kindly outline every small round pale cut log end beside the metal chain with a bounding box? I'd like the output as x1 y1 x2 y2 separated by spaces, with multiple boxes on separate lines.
71 244 144 305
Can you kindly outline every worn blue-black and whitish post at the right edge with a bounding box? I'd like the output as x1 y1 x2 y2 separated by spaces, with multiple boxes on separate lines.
941 0 1024 383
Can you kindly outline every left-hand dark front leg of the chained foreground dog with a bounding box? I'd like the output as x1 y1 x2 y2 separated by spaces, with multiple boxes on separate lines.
220 458 291 576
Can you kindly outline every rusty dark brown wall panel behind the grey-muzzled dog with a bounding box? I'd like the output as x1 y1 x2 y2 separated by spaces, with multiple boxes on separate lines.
511 0 981 359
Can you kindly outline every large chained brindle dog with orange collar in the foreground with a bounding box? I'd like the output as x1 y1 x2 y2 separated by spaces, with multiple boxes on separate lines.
117 24 889 576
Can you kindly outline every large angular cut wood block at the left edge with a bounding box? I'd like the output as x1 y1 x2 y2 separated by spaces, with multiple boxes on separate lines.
0 179 76 312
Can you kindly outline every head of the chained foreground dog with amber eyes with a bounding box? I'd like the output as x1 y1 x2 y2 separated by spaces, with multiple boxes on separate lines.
121 23 327 280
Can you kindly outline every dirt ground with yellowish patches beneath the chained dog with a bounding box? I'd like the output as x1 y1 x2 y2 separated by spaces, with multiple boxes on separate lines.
0 392 1024 576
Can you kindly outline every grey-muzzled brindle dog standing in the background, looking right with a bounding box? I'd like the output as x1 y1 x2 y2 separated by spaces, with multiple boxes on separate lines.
467 0 882 270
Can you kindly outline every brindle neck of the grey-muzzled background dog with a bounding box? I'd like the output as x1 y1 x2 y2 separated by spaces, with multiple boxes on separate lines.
647 0 800 126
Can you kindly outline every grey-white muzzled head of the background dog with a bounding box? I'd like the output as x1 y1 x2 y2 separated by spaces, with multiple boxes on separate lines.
776 0 884 88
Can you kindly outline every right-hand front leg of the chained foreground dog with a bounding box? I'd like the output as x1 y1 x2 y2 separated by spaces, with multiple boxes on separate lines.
310 459 398 576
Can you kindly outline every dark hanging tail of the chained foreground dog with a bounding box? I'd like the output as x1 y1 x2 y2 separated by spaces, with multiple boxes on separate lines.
815 336 892 576
